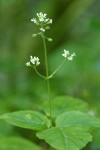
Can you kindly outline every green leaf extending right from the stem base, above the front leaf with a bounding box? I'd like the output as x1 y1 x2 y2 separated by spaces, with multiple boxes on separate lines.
56 111 100 127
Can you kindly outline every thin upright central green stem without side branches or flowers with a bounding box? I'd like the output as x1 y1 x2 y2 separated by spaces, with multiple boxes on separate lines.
41 33 52 126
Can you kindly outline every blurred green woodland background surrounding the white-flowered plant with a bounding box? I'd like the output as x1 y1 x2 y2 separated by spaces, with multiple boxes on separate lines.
0 0 100 150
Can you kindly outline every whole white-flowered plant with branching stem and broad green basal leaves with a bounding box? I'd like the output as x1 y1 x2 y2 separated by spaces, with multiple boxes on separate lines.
1 12 100 150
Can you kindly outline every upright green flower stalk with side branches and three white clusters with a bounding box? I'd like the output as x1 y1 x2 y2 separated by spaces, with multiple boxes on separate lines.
26 12 76 127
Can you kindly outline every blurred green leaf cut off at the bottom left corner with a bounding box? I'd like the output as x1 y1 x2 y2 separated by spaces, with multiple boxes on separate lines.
0 137 42 150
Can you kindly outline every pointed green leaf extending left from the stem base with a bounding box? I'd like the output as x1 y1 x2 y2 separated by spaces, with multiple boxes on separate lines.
0 110 50 131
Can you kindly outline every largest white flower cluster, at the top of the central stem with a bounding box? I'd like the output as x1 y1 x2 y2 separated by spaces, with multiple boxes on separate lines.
31 12 52 32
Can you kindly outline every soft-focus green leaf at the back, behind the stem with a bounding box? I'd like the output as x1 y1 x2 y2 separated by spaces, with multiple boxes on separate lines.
41 96 88 117
